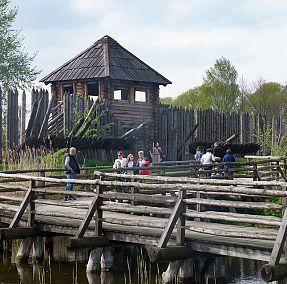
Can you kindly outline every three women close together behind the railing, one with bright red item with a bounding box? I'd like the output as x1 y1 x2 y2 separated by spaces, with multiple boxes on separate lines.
113 150 151 175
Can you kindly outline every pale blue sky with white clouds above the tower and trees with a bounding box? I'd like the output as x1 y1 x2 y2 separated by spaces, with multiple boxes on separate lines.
11 0 287 97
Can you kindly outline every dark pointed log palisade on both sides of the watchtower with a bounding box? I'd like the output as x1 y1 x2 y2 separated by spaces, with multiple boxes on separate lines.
0 89 287 160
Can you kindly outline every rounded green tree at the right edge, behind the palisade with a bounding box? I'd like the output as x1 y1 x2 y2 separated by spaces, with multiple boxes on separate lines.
246 80 287 118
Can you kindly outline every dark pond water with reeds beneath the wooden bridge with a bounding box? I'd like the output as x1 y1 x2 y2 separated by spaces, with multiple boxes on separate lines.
0 238 286 284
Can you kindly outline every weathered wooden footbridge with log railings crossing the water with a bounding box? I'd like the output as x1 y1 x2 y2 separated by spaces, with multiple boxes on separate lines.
0 161 287 280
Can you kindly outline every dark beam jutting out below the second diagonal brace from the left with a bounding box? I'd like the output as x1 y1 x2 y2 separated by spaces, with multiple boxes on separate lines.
66 237 111 250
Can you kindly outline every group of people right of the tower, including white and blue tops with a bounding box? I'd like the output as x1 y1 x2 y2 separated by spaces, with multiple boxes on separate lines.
194 142 236 177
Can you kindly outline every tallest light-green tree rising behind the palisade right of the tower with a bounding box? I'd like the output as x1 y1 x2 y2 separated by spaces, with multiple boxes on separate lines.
202 57 239 112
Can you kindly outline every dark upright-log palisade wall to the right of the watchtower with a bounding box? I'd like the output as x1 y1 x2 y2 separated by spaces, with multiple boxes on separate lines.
159 105 274 160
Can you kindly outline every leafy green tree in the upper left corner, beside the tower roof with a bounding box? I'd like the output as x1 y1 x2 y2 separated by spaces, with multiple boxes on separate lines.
0 0 39 91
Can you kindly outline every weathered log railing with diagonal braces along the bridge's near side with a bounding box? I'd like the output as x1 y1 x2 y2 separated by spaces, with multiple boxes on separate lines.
0 168 287 272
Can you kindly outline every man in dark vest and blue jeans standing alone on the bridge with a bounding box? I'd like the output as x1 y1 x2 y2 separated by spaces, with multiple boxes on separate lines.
64 147 80 201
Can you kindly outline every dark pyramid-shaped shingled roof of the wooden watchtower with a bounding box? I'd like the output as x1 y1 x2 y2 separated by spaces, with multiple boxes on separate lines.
40 36 171 85
